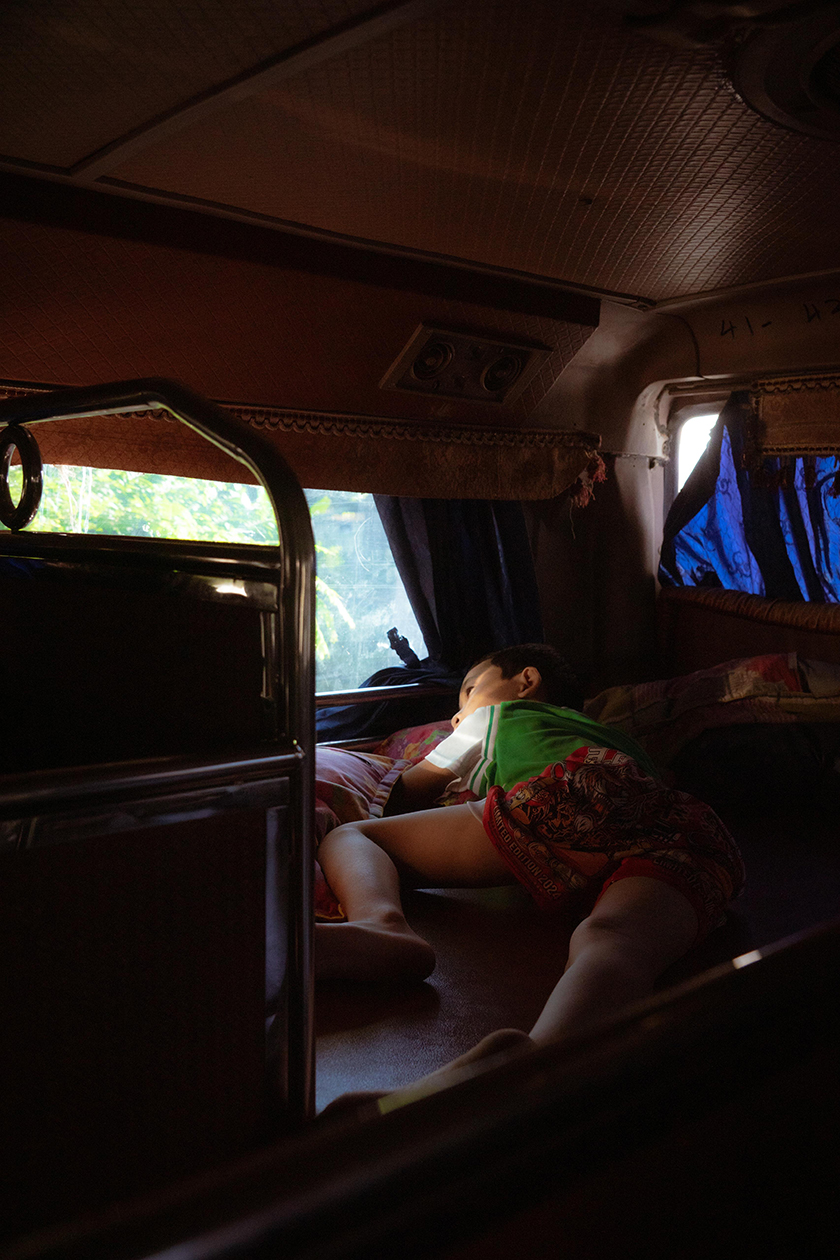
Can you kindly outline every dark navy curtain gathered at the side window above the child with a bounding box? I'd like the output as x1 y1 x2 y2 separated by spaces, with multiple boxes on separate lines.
316 495 543 740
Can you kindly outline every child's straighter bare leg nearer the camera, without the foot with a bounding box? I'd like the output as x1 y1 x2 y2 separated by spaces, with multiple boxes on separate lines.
530 876 698 1046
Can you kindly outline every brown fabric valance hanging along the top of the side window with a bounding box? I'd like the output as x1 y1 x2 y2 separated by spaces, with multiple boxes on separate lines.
0 386 602 500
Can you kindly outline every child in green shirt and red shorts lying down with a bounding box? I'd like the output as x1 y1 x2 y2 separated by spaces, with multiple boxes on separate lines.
315 644 744 1088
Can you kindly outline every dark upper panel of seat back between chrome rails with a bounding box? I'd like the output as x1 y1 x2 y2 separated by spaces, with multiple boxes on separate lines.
0 558 268 772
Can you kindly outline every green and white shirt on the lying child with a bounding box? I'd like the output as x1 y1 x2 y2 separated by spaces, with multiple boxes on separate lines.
426 701 659 796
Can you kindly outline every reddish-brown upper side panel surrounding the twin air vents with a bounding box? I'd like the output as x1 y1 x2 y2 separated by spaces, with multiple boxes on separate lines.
0 207 592 426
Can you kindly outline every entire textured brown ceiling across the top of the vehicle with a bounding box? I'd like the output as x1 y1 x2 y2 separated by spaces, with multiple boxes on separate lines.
0 0 840 301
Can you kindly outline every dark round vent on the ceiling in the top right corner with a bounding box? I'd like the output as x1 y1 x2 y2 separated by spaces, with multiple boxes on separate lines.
730 5 840 140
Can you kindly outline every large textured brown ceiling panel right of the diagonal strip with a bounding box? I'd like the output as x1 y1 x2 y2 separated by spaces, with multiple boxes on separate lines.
100 0 840 300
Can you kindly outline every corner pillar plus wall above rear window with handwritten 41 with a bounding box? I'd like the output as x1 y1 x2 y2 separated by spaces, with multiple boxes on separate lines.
528 273 840 694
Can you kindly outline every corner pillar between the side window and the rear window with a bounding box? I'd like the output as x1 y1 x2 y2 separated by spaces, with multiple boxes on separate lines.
526 302 698 696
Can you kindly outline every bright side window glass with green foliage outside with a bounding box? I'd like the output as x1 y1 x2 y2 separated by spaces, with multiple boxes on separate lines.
3 465 426 692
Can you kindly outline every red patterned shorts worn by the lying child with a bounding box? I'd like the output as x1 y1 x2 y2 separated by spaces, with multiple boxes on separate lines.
484 747 744 940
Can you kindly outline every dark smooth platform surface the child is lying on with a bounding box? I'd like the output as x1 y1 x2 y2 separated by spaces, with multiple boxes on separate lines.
315 808 840 1111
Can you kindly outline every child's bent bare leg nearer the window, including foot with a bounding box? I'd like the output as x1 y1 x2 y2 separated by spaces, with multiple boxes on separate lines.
315 805 513 980
